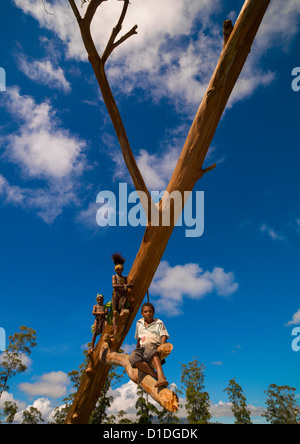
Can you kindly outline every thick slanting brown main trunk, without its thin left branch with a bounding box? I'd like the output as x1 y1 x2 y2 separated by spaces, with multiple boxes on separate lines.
66 0 271 424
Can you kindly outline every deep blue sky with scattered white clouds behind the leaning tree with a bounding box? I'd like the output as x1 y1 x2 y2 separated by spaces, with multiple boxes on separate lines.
0 0 300 422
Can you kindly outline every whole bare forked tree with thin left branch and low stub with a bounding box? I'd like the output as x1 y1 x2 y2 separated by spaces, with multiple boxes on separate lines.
66 0 271 424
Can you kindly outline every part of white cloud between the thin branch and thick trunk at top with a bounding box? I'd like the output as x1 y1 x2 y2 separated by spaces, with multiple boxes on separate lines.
102 0 222 107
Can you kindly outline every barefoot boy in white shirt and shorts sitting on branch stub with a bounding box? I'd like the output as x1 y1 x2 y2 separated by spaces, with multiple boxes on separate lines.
129 302 169 387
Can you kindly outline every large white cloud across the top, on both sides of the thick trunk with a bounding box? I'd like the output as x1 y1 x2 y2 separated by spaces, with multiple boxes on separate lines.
94 0 300 109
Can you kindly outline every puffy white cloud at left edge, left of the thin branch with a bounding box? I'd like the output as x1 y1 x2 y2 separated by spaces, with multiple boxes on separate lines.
0 88 86 223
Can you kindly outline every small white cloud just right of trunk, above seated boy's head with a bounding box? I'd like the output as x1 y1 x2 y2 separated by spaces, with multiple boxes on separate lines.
149 261 238 316
